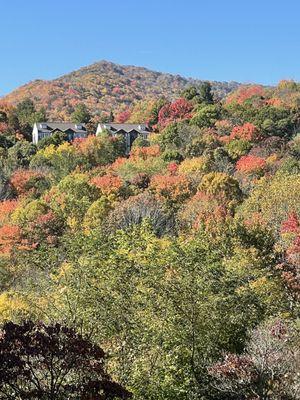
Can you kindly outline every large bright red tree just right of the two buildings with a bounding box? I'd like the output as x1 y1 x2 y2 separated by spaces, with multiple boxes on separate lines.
158 99 193 128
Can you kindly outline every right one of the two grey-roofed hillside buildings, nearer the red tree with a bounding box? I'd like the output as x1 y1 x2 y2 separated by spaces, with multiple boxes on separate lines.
96 123 150 154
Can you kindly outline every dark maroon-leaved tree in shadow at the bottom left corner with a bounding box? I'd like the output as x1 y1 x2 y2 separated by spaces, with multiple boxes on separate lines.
0 321 131 400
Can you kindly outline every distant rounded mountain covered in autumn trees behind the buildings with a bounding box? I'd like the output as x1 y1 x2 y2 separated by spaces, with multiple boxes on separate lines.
3 61 239 119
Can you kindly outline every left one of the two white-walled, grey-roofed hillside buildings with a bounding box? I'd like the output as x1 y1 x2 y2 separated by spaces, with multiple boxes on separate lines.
32 122 87 144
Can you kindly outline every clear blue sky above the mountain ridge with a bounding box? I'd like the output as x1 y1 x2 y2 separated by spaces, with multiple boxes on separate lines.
0 0 300 96
